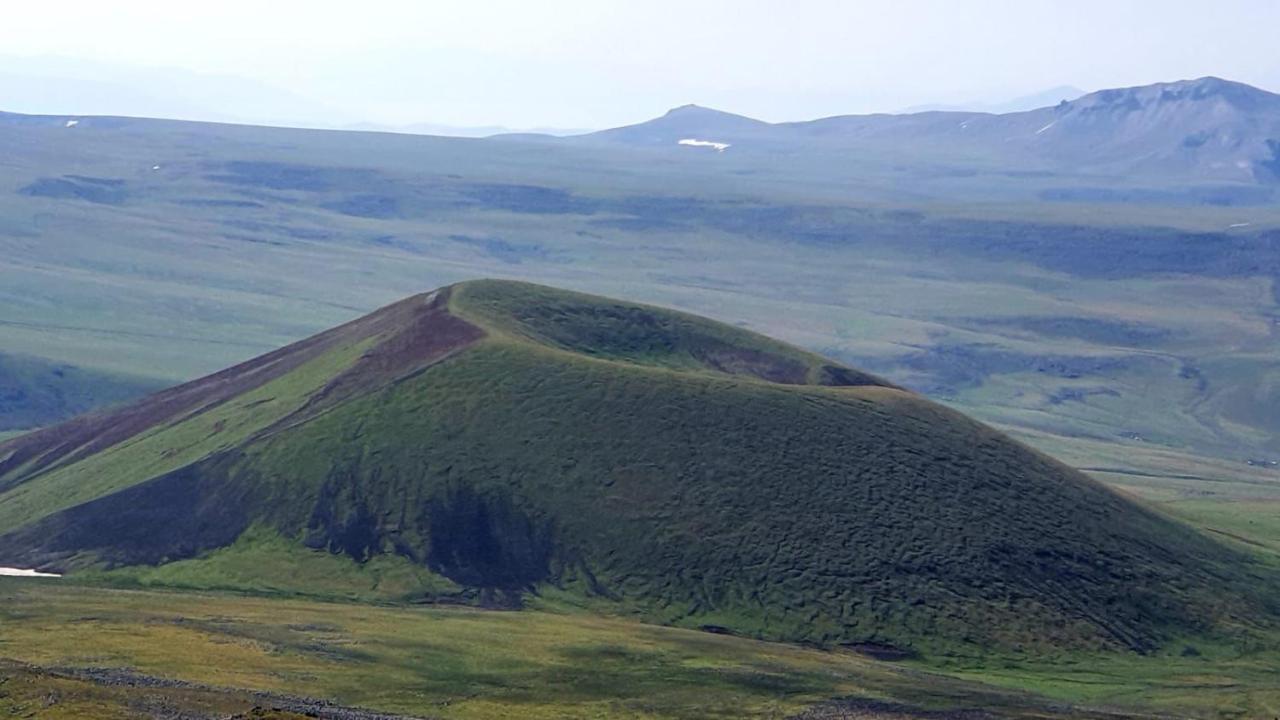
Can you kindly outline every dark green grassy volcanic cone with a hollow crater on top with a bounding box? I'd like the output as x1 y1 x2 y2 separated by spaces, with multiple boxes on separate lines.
0 281 1274 650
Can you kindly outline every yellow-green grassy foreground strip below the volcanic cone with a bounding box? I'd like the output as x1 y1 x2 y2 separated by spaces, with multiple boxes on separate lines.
0 579 1280 720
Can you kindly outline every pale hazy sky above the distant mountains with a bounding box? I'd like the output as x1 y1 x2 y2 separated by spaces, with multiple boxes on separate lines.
0 0 1280 127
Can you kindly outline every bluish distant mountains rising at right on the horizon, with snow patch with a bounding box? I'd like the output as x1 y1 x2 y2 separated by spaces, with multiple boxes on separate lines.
575 77 1280 184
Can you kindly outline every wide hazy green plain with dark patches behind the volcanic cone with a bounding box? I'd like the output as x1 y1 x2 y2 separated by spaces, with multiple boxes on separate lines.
0 105 1280 502
